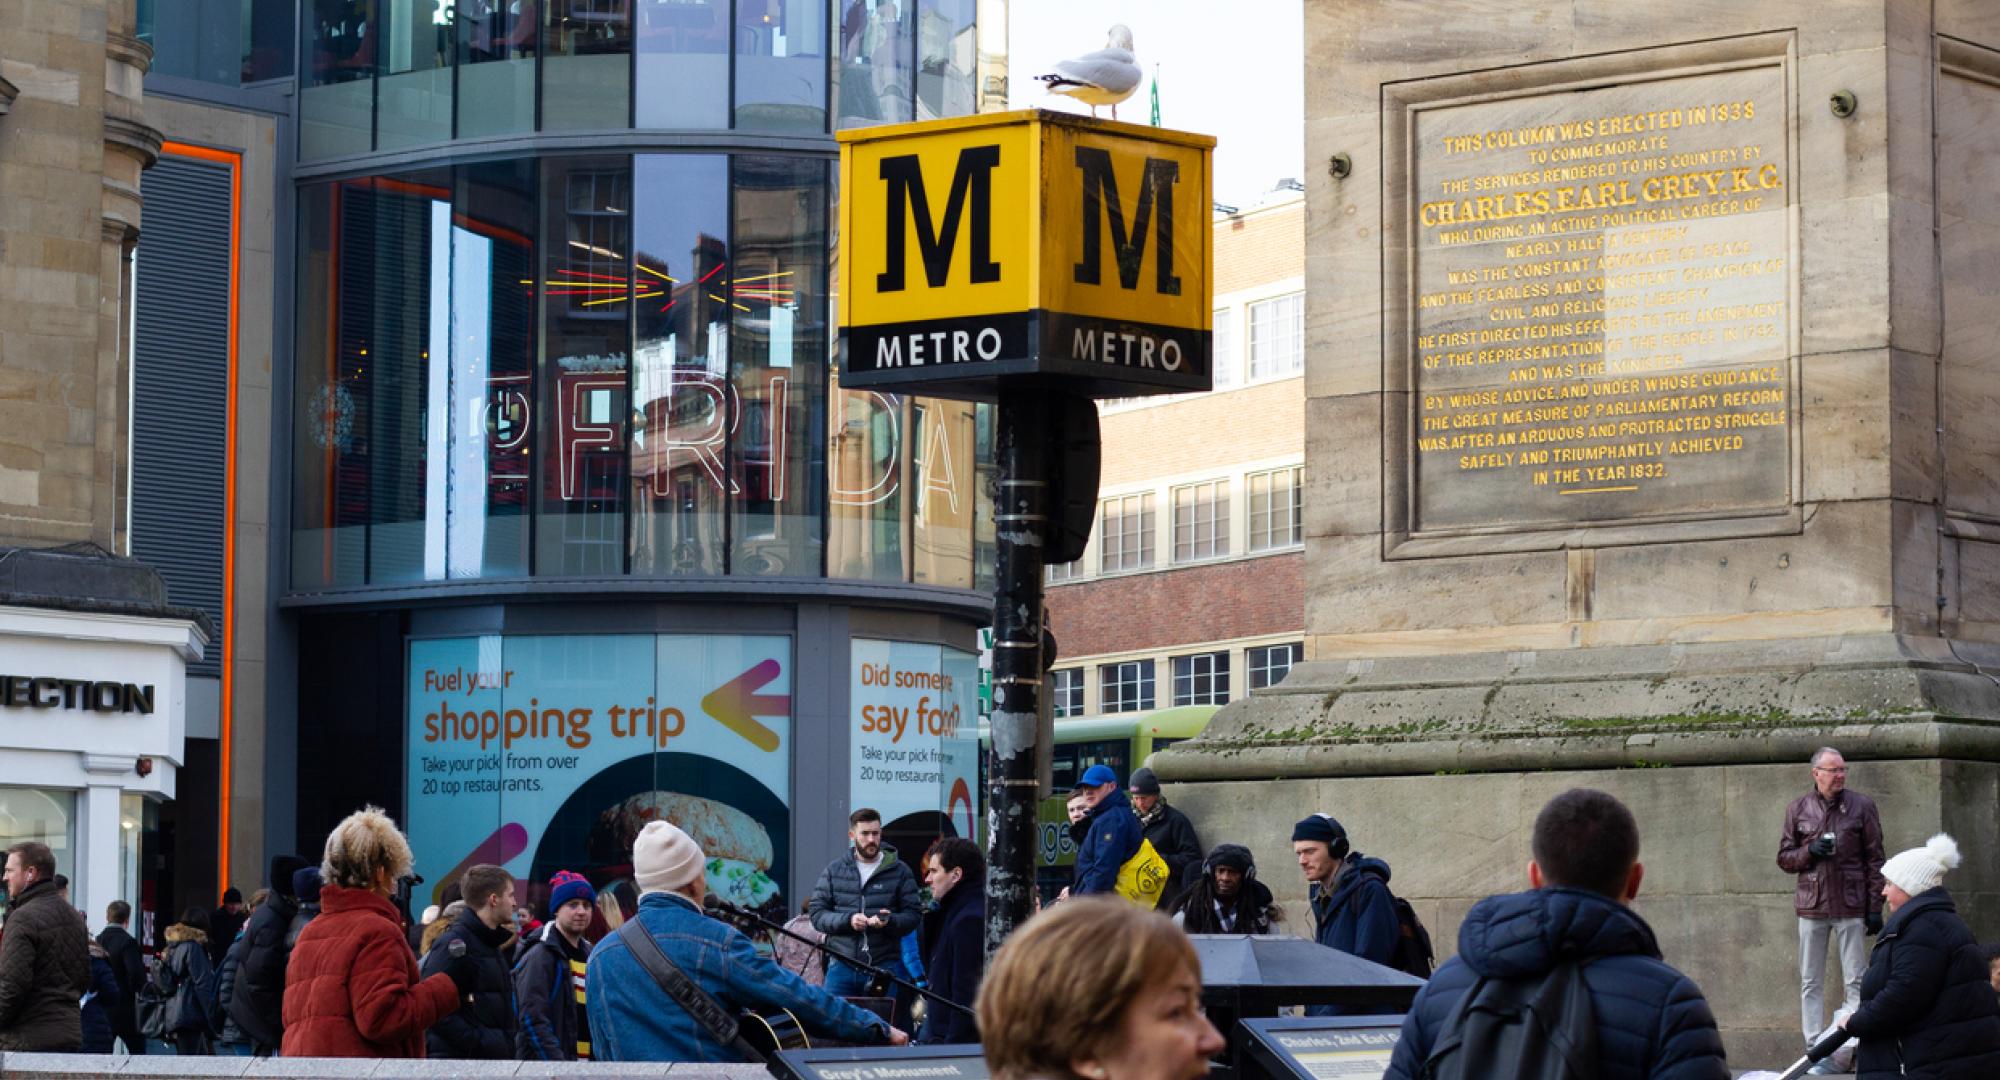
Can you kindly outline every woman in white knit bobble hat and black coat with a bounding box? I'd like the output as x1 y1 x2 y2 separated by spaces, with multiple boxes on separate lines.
1846 832 2000 1080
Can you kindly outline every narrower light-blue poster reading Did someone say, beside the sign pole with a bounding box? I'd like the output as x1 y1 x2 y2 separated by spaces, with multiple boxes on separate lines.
848 638 980 862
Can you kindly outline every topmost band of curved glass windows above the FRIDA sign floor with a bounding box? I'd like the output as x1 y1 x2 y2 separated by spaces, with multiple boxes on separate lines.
298 0 978 160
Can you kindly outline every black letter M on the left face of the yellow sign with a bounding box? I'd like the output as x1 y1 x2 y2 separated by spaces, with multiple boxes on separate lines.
876 146 1000 292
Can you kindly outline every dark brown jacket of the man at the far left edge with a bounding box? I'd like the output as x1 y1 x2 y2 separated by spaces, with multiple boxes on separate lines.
0 880 90 1052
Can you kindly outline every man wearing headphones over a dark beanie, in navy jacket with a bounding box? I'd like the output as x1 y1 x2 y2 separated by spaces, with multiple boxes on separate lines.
1292 814 1402 1016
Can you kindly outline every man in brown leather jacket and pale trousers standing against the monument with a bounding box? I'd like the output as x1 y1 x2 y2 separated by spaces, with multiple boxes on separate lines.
1778 746 1884 1046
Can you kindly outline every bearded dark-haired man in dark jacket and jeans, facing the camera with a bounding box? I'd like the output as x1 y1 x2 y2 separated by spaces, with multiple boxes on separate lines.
806 806 924 1028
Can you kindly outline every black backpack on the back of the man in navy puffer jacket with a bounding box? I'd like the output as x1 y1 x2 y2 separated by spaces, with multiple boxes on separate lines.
1422 962 1598 1080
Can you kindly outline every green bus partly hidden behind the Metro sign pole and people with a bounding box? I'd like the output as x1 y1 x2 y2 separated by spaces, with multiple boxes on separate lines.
980 706 1222 902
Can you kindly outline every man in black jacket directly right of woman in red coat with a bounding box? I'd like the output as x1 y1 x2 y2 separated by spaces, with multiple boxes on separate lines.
424 862 516 1060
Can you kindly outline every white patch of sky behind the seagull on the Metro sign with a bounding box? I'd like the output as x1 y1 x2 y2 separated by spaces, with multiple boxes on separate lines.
1008 0 1306 206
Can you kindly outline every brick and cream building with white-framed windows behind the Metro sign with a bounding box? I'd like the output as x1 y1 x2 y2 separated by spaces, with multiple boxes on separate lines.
1048 188 1306 718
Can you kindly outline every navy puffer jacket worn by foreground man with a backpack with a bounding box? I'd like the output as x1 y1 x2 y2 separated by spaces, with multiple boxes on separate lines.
1384 888 1730 1080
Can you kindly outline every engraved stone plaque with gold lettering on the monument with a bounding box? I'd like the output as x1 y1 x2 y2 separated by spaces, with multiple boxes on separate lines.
1384 46 1798 544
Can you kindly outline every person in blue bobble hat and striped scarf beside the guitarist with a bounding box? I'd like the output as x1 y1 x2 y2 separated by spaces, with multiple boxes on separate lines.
514 870 598 1062
